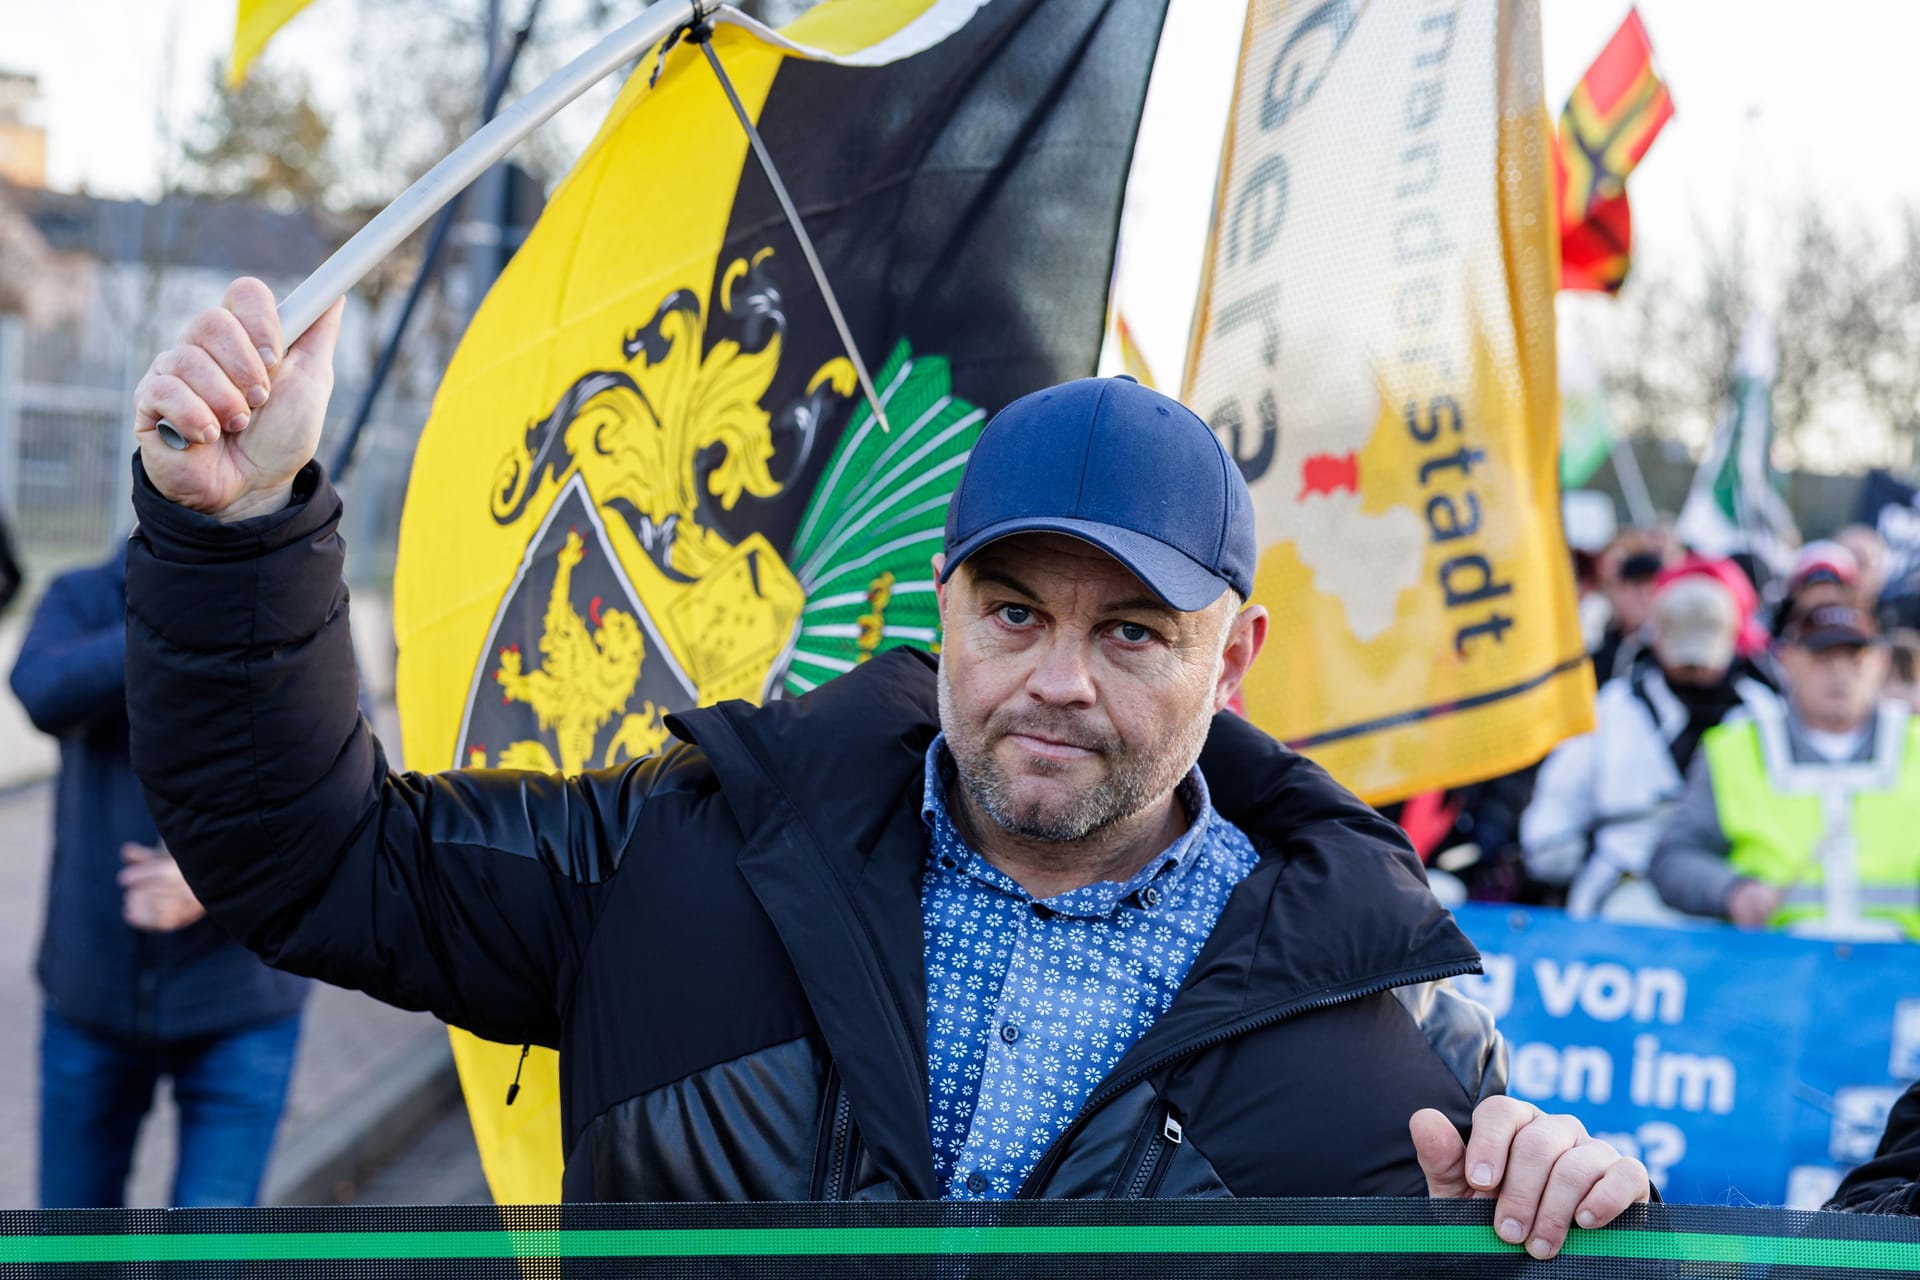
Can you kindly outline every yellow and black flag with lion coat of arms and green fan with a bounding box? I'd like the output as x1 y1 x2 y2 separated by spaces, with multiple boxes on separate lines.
394 0 1165 1201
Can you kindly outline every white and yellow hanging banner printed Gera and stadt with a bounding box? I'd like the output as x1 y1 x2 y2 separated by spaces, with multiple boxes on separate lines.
1185 0 1592 802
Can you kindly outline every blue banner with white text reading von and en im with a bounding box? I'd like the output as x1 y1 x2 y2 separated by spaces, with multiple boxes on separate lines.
1453 904 1920 1209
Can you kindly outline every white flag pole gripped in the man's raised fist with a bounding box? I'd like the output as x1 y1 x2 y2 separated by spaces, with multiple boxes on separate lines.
159 0 716 449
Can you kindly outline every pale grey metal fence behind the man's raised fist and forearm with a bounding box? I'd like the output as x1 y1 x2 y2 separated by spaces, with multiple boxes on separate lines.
0 315 426 585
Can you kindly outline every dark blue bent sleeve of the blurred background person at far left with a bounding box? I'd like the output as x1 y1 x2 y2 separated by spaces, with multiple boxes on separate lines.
12 574 127 737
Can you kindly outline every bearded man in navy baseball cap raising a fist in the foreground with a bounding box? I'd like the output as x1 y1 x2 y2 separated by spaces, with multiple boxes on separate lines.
127 268 1647 1228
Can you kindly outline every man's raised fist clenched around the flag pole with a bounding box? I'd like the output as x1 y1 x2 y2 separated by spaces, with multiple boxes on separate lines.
134 276 342 520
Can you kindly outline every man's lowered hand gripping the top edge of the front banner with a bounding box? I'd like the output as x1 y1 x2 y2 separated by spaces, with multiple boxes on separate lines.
1409 1098 1653 1257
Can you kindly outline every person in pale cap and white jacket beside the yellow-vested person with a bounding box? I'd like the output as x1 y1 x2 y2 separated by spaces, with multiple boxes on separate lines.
1521 574 1774 917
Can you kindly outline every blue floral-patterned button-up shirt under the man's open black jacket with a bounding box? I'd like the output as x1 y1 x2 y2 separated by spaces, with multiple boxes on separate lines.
920 737 1260 1199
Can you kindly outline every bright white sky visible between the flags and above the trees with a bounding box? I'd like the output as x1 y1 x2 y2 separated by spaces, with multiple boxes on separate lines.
0 0 1920 384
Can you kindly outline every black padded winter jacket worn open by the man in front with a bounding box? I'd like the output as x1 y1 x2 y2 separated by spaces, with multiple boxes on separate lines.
127 470 1503 1199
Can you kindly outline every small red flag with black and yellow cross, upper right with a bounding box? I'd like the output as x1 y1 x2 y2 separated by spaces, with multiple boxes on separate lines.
1553 10 1674 294
